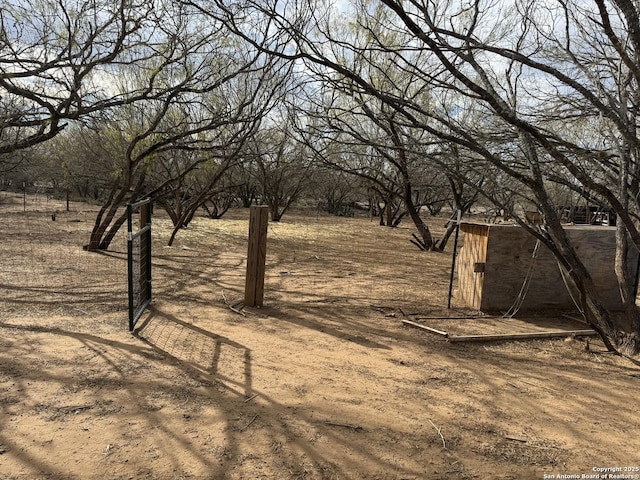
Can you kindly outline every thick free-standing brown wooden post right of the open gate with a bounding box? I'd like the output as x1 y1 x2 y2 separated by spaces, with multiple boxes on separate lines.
244 205 269 307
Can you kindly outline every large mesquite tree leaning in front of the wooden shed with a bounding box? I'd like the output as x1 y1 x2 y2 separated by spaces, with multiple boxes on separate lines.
204 0 640 354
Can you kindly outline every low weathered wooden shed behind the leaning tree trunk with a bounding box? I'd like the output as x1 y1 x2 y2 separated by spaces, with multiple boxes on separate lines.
456 223 638 312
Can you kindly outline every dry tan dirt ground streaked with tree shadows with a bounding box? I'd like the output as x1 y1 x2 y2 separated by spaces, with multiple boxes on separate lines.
0 192 640 479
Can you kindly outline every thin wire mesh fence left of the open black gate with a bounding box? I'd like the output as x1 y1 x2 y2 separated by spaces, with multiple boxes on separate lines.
0 192 127 320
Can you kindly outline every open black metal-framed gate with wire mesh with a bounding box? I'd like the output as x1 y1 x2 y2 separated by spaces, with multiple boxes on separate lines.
127 198 152 331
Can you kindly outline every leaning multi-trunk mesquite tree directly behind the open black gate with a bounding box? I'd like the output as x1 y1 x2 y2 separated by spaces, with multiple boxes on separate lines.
84 4 287 250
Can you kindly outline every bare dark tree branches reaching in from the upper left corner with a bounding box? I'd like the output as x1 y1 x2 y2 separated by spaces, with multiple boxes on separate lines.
0 0 175 155
